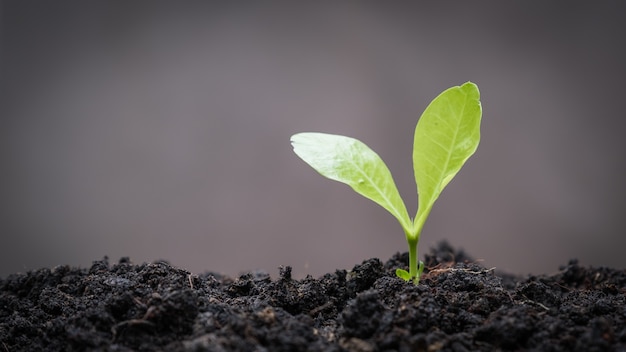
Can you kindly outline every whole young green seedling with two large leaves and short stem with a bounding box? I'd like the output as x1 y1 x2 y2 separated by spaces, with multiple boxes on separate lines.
291 82 482 285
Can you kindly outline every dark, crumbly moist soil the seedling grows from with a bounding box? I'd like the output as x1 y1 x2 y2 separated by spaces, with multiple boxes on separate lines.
0 243 626 352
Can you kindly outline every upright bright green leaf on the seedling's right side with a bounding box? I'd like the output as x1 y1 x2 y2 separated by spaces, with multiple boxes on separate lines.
413 82 482 239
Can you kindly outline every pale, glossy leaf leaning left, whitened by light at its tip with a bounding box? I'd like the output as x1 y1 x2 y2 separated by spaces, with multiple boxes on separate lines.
291 132 412 233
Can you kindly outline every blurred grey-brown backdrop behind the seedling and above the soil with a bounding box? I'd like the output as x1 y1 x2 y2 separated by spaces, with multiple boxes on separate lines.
0 0 626 277
